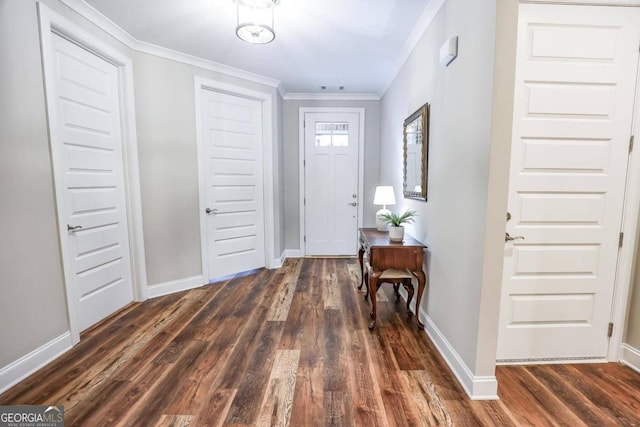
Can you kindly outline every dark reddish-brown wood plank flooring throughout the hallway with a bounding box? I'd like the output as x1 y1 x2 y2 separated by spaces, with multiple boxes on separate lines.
0 259 640 427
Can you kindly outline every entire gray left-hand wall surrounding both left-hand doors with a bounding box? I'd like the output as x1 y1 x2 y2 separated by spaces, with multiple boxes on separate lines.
0 0 284 376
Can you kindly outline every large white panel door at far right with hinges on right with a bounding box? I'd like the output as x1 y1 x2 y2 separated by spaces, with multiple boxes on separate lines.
498 4 640 361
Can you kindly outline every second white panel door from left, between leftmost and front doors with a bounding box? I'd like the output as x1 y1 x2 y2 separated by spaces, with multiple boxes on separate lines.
201 89 265 280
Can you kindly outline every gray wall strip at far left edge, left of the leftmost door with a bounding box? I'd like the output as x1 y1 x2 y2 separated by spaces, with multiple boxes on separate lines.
0 0 69 367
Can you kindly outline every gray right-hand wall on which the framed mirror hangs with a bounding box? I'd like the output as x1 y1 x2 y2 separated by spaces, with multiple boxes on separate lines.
380 0 508 375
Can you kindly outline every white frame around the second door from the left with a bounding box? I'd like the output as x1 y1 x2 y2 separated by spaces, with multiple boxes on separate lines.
195 76 280 281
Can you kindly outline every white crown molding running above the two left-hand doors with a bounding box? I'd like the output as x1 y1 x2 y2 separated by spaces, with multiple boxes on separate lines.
60 0 280 88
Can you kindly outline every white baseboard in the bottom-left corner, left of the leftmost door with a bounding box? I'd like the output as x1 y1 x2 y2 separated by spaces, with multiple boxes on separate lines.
0 331 73 393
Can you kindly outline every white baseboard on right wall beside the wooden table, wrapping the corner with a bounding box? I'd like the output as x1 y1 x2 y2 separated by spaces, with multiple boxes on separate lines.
416 304 499 400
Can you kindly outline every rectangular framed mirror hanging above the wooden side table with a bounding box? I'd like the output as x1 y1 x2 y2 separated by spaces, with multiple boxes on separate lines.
402 103 429 201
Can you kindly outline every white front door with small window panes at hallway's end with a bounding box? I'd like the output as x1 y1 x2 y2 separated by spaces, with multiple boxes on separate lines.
303 113 360 255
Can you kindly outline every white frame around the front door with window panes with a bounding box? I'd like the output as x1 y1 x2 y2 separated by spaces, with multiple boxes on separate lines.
298 107 365 257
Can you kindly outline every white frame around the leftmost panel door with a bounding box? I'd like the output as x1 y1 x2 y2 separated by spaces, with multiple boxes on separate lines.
38 2 148 345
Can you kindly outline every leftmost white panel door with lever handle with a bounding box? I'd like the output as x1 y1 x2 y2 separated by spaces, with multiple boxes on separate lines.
47 35 133 331
